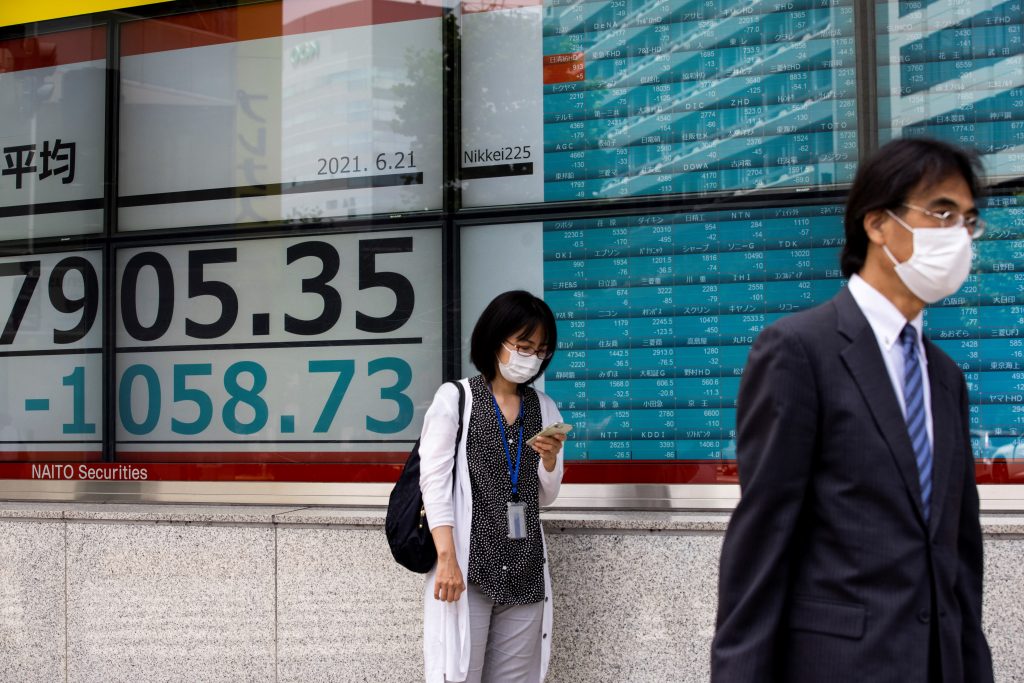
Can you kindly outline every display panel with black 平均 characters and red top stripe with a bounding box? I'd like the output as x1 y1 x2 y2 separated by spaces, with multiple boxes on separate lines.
0 27 106 240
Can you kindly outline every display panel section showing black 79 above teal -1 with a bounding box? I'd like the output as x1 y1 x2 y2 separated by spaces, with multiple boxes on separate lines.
0 251 103 463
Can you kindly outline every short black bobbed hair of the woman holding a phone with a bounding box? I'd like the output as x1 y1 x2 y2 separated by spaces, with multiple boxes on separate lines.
469 290 558 384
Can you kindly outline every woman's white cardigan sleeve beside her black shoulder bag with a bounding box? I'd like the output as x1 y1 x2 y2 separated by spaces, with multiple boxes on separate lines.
420 382 459 529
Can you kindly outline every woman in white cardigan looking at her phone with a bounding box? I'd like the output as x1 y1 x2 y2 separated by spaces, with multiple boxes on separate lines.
420 291 565 683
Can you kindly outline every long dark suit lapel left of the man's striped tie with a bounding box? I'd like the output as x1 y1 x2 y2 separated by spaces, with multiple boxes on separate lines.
833 289 934 525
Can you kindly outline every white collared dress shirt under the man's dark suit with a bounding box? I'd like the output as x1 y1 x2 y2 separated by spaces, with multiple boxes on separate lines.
848 274 935 452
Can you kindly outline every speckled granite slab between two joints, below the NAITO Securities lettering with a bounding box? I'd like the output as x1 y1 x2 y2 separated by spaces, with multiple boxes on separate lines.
67 522 274 683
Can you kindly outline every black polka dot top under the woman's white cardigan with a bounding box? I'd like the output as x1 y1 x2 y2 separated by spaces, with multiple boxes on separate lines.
466 375 544 605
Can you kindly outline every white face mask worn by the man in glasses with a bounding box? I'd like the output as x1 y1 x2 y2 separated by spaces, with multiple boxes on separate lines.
882 209 974 303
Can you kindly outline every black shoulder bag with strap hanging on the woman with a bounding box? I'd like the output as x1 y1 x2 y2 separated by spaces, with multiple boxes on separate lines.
384 382 466 573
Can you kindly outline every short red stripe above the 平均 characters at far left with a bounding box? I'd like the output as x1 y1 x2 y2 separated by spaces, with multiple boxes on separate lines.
0 27 106 74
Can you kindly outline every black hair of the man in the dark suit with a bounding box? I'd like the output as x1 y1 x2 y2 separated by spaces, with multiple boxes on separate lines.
840 137 983 278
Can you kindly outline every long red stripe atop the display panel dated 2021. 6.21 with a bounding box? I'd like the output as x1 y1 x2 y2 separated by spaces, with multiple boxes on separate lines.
121 0 441 56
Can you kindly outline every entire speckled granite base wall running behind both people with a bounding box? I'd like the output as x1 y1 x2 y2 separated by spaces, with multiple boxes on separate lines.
0 502 1024 683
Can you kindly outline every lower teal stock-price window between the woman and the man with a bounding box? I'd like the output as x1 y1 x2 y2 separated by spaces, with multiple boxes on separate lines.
462 205 843 483
